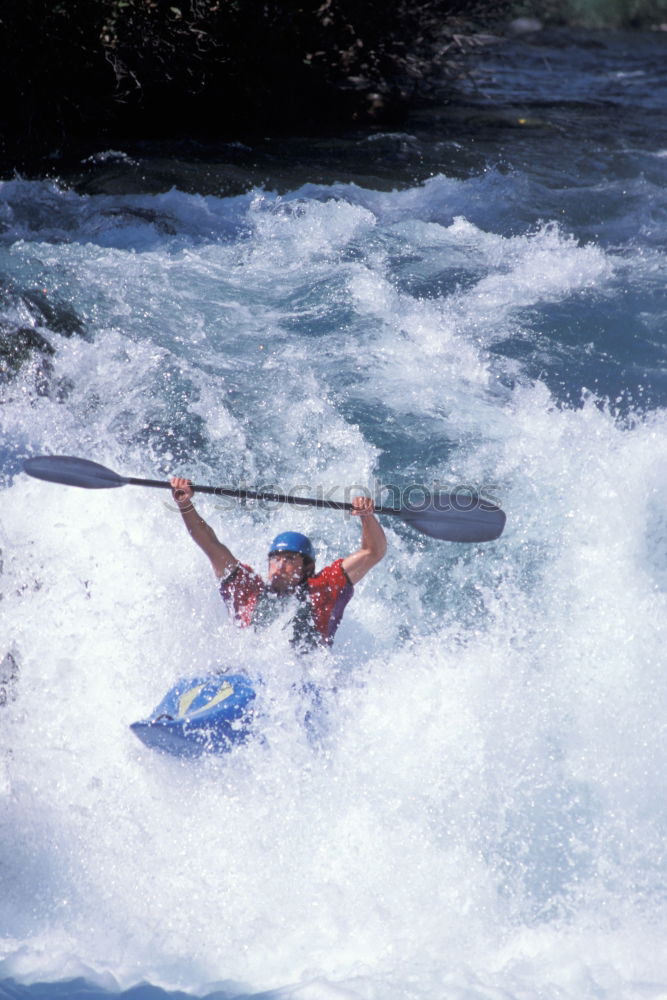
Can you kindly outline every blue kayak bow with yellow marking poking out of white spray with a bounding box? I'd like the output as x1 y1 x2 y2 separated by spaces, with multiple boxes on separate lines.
130 674 256 757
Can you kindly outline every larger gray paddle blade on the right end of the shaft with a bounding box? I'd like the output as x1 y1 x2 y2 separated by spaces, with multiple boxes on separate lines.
400 493 506 542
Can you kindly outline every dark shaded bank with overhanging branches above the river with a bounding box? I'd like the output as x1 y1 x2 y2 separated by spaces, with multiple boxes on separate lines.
0 0 511 173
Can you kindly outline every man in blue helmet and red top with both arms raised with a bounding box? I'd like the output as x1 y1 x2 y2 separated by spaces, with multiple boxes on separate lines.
171 476 387 651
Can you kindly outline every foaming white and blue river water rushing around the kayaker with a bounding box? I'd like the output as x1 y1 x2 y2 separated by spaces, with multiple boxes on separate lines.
0 27 667 1000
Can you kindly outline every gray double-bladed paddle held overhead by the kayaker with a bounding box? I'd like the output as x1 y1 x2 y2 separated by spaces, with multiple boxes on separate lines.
23 455 505 542
